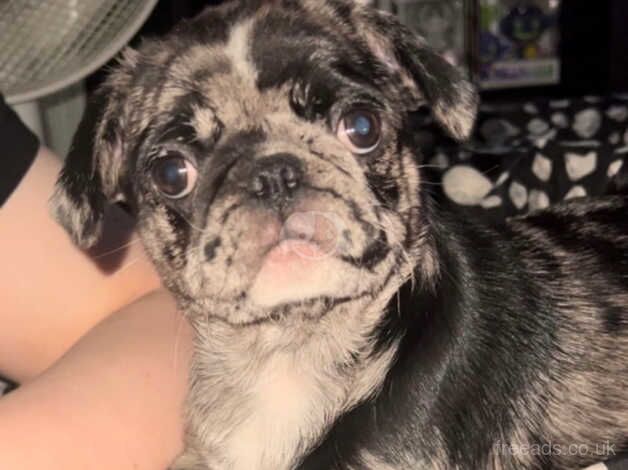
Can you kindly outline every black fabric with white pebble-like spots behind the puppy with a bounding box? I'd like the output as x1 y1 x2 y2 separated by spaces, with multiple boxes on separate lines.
428 95 628 218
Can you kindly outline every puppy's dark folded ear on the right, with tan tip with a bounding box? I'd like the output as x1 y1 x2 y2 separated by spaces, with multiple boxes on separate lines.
360 8 479 140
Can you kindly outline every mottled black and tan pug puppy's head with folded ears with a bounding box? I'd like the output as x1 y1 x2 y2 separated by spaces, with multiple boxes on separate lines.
56 0 475 324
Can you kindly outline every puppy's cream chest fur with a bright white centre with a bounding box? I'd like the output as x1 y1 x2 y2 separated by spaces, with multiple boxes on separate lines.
188 304 394 470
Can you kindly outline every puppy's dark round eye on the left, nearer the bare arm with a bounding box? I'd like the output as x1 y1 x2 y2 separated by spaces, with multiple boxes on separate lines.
151 151 197 199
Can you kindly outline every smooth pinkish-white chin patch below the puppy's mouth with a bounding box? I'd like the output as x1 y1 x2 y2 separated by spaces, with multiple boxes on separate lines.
248 240 346 309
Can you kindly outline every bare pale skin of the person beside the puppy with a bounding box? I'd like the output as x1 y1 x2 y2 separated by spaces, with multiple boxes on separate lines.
0 149 192 470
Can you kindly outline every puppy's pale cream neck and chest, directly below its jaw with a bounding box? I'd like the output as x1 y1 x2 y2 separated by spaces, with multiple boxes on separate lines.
182 268 404 470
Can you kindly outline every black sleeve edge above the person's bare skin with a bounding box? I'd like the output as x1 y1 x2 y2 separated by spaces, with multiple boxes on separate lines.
0 94 39 206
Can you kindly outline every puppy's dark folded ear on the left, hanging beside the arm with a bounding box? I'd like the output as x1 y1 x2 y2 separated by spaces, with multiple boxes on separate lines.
50 50 134 248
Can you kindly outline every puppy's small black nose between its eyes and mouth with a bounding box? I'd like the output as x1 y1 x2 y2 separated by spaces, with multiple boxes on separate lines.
249 153 303 203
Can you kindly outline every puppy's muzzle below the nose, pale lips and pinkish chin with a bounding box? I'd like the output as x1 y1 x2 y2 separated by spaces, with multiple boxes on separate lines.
195 198 388 316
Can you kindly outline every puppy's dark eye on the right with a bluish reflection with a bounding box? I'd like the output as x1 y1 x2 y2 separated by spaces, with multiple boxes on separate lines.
337 110 382 155
